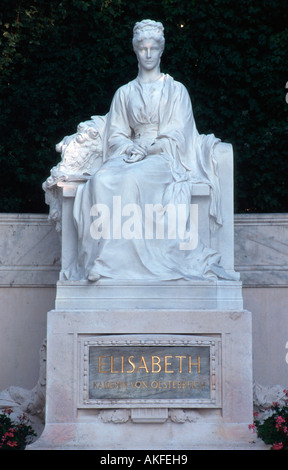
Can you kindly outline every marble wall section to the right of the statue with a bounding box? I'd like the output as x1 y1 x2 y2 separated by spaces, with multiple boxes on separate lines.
235 214 288 387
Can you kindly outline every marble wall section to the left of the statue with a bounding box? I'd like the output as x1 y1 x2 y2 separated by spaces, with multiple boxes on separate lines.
0 214 60 391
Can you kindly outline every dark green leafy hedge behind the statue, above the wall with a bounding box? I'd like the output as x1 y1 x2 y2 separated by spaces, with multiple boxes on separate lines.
0 0 288 212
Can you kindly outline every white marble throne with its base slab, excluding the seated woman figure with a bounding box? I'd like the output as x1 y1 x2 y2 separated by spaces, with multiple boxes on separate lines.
43 116 243 309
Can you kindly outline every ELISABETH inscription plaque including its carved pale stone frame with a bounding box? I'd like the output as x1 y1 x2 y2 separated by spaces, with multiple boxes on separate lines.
81 335 220 407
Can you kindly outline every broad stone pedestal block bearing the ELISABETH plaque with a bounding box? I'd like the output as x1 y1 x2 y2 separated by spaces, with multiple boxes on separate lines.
30 298 253 450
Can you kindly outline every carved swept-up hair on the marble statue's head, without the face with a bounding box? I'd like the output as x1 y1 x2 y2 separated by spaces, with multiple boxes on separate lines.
132 20 165 52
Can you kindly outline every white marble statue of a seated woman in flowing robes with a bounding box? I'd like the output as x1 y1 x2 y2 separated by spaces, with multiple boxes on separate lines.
67 20 229 282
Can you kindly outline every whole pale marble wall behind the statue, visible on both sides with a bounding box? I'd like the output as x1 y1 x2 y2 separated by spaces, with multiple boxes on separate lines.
0 214 288 391
